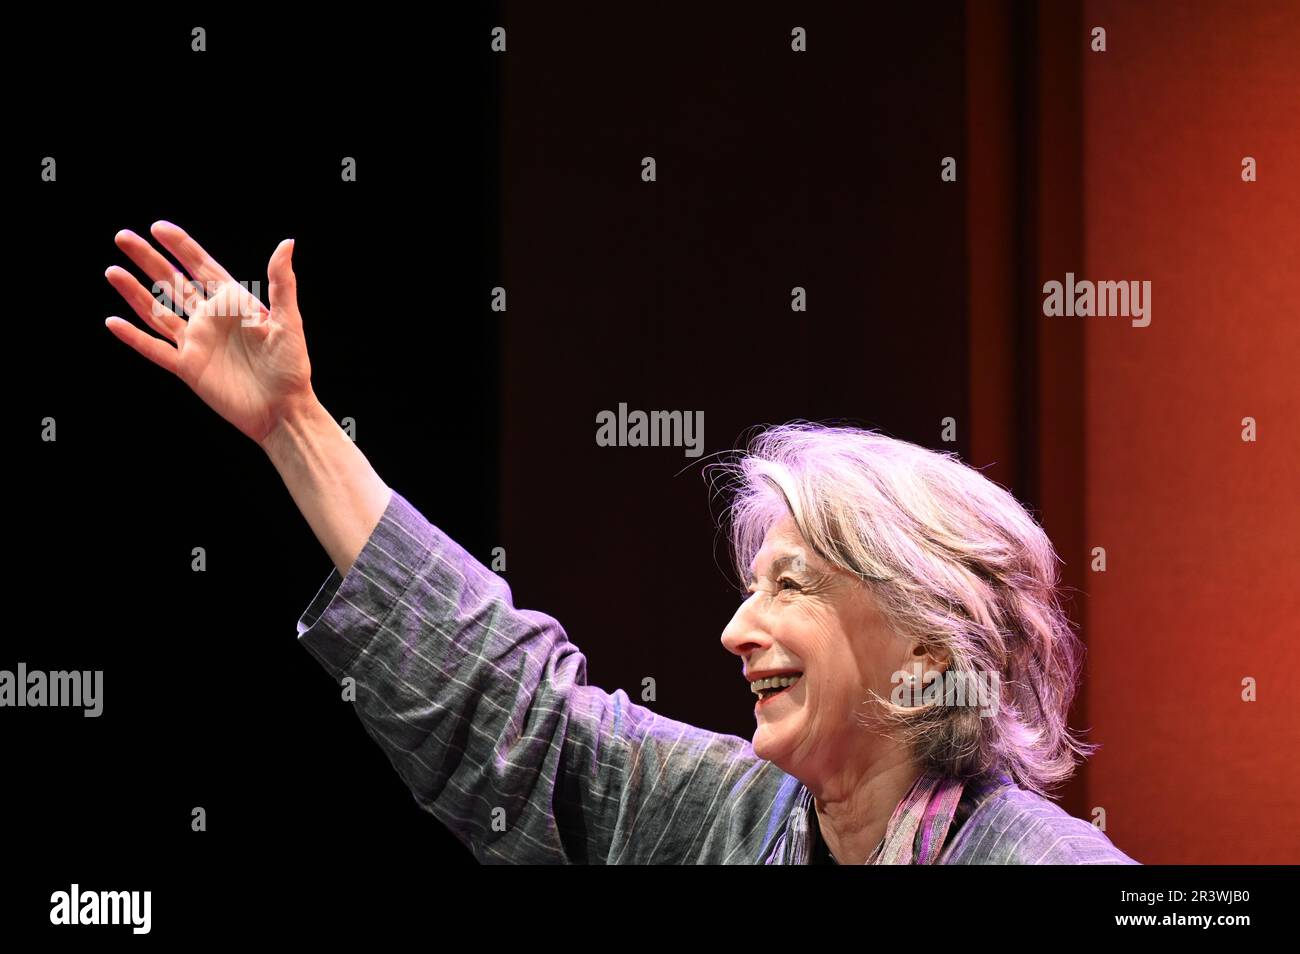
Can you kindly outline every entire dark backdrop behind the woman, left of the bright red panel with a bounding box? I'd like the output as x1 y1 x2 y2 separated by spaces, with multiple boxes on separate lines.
0 4 1289 932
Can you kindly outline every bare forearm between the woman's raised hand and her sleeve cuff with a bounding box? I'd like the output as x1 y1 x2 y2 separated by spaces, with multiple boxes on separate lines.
261 394 391 576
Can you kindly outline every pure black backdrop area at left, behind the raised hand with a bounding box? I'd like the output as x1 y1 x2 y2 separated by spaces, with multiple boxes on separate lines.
10 5 499 933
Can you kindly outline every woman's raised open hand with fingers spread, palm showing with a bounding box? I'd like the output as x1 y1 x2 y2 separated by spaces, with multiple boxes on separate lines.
108 222 311 442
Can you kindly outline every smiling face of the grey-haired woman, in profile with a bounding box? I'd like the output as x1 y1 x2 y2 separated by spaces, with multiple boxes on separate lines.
722 516 926 782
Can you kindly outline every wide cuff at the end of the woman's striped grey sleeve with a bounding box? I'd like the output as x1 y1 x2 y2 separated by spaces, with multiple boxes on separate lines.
298 490 437 681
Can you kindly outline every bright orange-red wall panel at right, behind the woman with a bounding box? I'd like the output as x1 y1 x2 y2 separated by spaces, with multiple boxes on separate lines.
1076 1 1300 863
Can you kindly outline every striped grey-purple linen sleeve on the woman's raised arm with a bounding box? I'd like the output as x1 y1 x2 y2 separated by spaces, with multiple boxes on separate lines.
298 491 772 863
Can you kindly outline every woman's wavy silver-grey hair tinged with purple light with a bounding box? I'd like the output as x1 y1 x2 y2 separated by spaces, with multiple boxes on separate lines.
710 421 1097 795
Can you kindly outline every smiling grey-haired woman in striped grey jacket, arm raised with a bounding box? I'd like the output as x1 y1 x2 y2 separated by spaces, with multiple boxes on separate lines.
105 222 1135 864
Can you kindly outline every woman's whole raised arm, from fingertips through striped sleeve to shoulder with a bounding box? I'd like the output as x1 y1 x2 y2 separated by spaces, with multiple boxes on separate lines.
105 222 796 863
